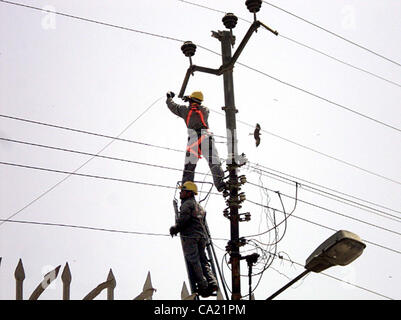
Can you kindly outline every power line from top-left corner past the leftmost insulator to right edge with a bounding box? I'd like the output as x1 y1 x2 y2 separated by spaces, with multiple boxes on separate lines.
0 0 401 133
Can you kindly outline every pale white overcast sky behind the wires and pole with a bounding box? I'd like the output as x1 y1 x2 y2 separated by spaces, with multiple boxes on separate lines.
0 0 401 299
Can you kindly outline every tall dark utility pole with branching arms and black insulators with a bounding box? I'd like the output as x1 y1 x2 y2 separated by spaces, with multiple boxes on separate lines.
178 0 278 300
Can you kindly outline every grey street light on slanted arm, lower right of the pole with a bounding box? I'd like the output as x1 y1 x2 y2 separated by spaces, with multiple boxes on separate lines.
266 230 366 300
